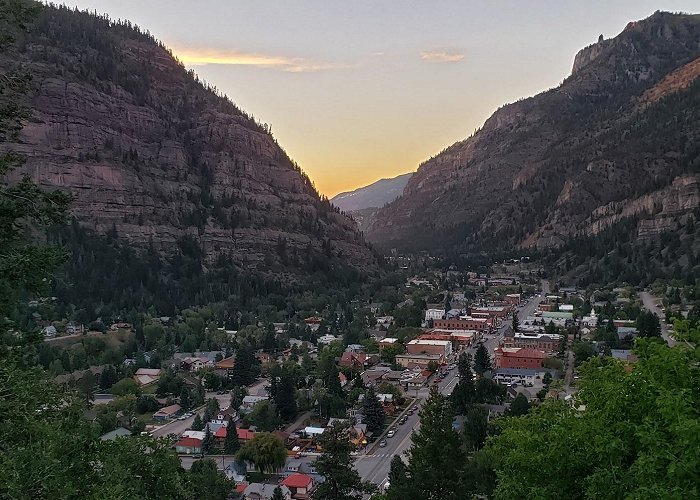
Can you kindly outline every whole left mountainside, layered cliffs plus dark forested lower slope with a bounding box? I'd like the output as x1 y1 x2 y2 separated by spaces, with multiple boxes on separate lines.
0 1 377 313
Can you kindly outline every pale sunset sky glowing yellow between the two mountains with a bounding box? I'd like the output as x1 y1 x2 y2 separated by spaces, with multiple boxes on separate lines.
58 0 700 197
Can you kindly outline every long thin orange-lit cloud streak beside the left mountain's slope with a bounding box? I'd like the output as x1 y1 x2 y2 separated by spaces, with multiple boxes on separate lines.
173 49 347 73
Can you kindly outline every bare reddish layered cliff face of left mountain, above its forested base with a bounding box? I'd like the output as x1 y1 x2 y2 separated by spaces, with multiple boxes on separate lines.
0 7 376 274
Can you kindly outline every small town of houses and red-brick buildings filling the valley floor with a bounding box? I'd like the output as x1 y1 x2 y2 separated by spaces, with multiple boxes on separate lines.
35 257 680 500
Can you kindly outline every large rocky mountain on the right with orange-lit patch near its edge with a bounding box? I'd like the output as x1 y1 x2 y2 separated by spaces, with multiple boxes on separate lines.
367 12 700 278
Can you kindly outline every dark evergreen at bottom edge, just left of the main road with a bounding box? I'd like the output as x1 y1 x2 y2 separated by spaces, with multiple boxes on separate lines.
314 423 376 500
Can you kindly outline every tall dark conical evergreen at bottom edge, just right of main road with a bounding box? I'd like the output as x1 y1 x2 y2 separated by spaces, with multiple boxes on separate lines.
408 385 466 500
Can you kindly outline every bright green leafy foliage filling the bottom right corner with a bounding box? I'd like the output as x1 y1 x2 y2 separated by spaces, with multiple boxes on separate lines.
486 339 700 499
